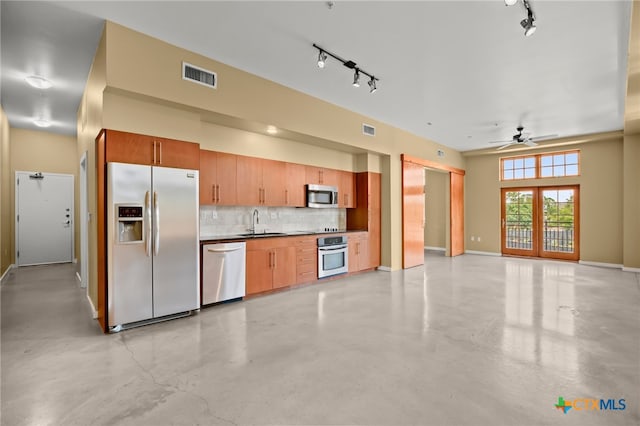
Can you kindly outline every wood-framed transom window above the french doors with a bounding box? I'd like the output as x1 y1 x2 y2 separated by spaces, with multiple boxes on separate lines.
500 151 580 180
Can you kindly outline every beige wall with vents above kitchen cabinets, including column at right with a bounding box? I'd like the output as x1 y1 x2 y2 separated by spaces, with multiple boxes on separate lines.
95 22 465 276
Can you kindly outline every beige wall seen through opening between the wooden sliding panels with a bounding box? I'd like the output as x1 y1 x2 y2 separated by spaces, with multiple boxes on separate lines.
424 169 449 249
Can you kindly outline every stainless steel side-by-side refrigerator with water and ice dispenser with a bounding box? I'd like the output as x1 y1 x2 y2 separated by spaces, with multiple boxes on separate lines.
107 163 200 331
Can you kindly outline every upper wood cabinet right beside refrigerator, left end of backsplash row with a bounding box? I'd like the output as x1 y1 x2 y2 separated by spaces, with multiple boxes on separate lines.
200 150 237 206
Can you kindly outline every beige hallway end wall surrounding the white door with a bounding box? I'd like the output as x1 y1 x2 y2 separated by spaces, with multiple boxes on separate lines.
9 128 80 263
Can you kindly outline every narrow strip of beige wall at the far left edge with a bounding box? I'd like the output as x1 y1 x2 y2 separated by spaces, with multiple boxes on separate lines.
0 107 13 276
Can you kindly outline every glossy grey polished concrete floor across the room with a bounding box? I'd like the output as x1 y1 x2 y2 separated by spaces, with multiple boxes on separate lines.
0 254 640 425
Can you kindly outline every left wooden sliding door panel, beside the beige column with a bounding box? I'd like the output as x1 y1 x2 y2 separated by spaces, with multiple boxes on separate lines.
402 161 424 268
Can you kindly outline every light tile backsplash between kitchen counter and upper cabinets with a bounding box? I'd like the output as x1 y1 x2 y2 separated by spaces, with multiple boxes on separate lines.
200 206 347 236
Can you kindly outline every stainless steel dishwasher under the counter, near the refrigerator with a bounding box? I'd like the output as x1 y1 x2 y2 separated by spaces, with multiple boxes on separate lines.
202 242 247 305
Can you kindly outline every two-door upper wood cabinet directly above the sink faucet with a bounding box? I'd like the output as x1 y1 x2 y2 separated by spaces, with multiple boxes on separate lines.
236 155 286 206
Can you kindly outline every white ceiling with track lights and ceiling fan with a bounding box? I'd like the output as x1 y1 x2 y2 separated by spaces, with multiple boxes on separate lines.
1 0 631 151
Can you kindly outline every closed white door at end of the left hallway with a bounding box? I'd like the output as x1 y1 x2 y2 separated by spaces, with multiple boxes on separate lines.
15 172 73 266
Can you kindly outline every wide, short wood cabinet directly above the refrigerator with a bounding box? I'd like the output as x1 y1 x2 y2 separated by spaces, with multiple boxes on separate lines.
104 130 200 170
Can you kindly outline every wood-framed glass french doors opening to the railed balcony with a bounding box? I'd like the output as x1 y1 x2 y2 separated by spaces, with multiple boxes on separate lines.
501 185 580 260
